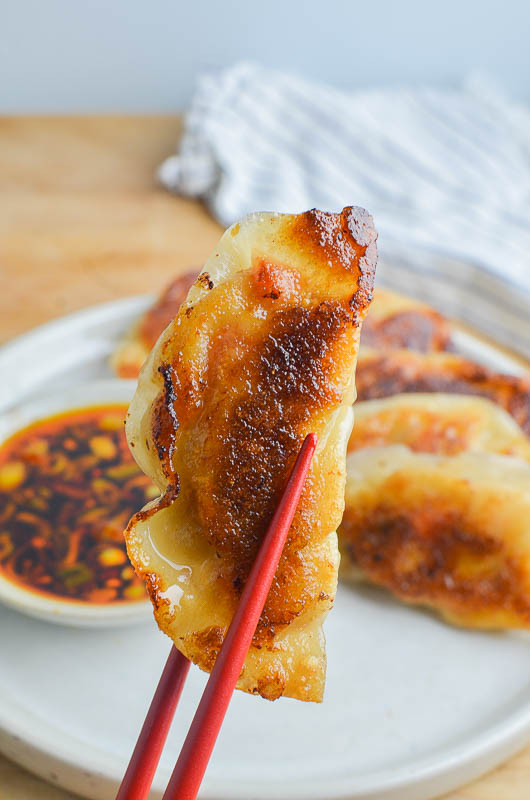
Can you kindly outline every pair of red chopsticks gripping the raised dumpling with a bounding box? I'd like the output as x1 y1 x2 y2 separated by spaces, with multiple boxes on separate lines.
116 433 317 800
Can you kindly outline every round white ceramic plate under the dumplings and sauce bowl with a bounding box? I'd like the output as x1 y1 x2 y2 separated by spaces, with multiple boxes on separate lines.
0 257 530 800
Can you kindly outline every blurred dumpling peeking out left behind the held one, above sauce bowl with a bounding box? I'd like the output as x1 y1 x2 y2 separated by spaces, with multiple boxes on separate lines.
110 270 198 378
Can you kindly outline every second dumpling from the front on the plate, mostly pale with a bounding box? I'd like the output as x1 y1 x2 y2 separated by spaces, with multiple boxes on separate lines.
348 394 530 462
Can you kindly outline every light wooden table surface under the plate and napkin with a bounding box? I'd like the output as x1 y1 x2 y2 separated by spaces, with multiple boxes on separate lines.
0 116 530 800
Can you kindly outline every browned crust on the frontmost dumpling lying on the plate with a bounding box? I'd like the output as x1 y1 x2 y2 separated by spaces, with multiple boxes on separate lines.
340 484 530 628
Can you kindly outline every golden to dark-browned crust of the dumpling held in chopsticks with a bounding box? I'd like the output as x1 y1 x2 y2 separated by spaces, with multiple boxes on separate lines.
129 208 377 699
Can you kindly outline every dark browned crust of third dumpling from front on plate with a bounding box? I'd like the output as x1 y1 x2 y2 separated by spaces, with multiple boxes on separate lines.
356 348 530 436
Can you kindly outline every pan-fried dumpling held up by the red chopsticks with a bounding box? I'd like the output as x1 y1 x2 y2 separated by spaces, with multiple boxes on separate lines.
126 208 376 701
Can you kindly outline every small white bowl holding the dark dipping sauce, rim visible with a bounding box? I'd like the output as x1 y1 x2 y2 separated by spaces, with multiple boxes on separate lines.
0 379 152 628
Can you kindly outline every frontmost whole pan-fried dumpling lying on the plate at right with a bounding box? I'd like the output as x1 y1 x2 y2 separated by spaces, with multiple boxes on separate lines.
339 445 530 628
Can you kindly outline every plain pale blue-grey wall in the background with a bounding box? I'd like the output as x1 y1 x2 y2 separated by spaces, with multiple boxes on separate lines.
0 0 530 112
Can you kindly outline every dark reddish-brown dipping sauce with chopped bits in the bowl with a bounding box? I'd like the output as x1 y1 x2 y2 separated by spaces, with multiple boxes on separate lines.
0 404 155 604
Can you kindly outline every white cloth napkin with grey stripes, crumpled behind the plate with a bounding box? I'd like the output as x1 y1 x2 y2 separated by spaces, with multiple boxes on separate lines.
158 63 530 289
